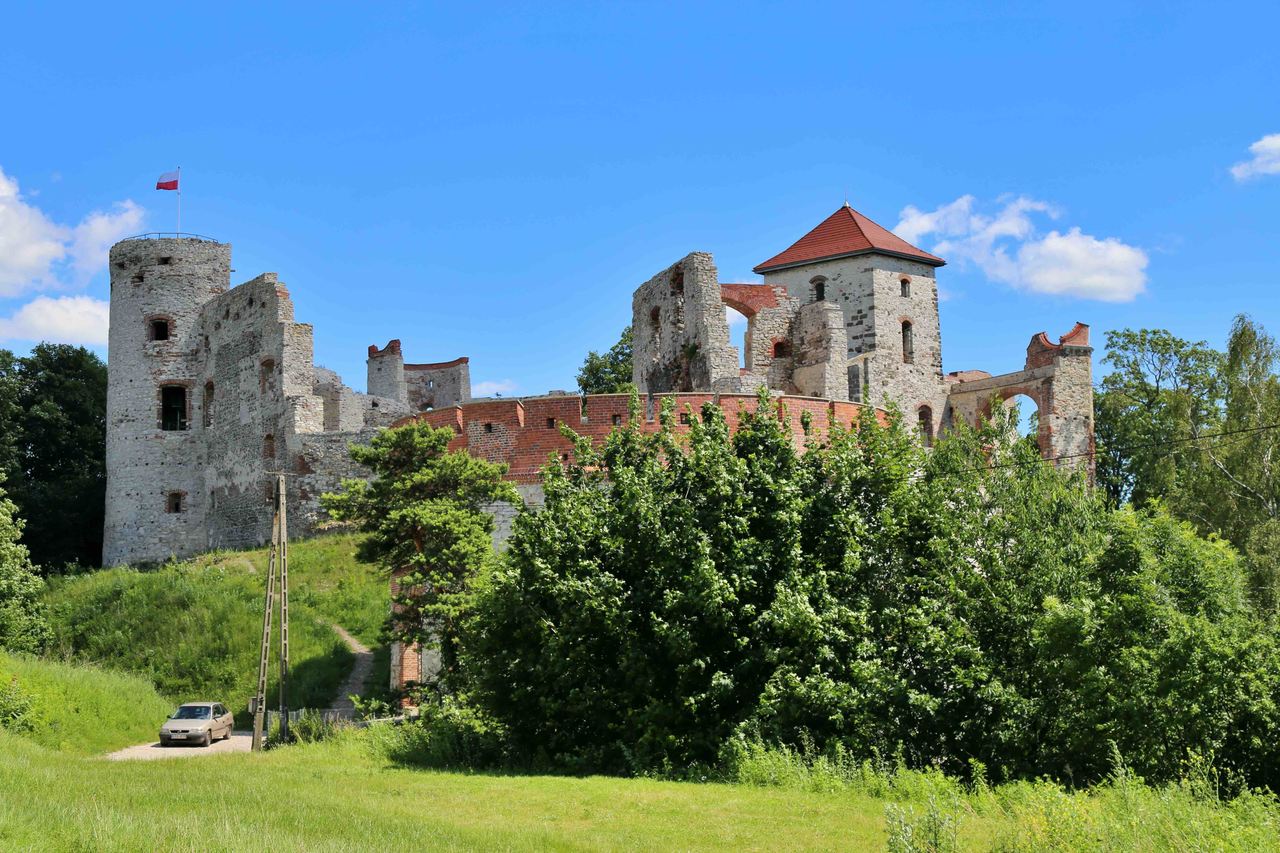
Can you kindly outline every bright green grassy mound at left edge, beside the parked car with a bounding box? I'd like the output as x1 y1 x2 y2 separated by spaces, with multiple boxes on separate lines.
0 652 173 754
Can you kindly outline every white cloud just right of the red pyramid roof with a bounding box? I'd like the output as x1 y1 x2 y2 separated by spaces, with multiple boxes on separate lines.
893 196 1147 302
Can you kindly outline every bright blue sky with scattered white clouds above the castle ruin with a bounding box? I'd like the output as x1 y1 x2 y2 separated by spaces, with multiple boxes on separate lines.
0 3 1280 394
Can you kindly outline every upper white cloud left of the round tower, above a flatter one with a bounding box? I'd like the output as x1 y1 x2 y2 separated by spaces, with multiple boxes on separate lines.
0 169 143 297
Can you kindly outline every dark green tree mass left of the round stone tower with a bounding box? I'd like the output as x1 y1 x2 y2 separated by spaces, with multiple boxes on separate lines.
0 343 106 573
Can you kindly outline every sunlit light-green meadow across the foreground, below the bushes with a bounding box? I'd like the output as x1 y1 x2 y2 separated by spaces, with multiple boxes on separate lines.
0 729 1280 852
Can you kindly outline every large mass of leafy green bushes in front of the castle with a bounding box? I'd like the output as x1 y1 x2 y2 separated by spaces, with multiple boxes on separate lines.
463 397 1280 784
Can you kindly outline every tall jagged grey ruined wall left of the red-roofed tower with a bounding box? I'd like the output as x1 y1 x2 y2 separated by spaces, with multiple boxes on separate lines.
631 252 739 393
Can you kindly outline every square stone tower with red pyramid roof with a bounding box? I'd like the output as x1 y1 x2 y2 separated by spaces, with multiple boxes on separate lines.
755 202 948 437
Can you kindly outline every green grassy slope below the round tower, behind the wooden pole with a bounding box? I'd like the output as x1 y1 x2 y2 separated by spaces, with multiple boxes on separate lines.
46 537 389 724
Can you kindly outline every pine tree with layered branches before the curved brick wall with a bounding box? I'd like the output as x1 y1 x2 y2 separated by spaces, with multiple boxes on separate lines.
321 424 520 681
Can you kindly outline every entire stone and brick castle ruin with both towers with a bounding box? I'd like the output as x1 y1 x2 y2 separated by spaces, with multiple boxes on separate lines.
102 205 1093 578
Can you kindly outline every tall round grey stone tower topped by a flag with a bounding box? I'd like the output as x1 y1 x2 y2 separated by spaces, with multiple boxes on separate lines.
102 234 232 566
